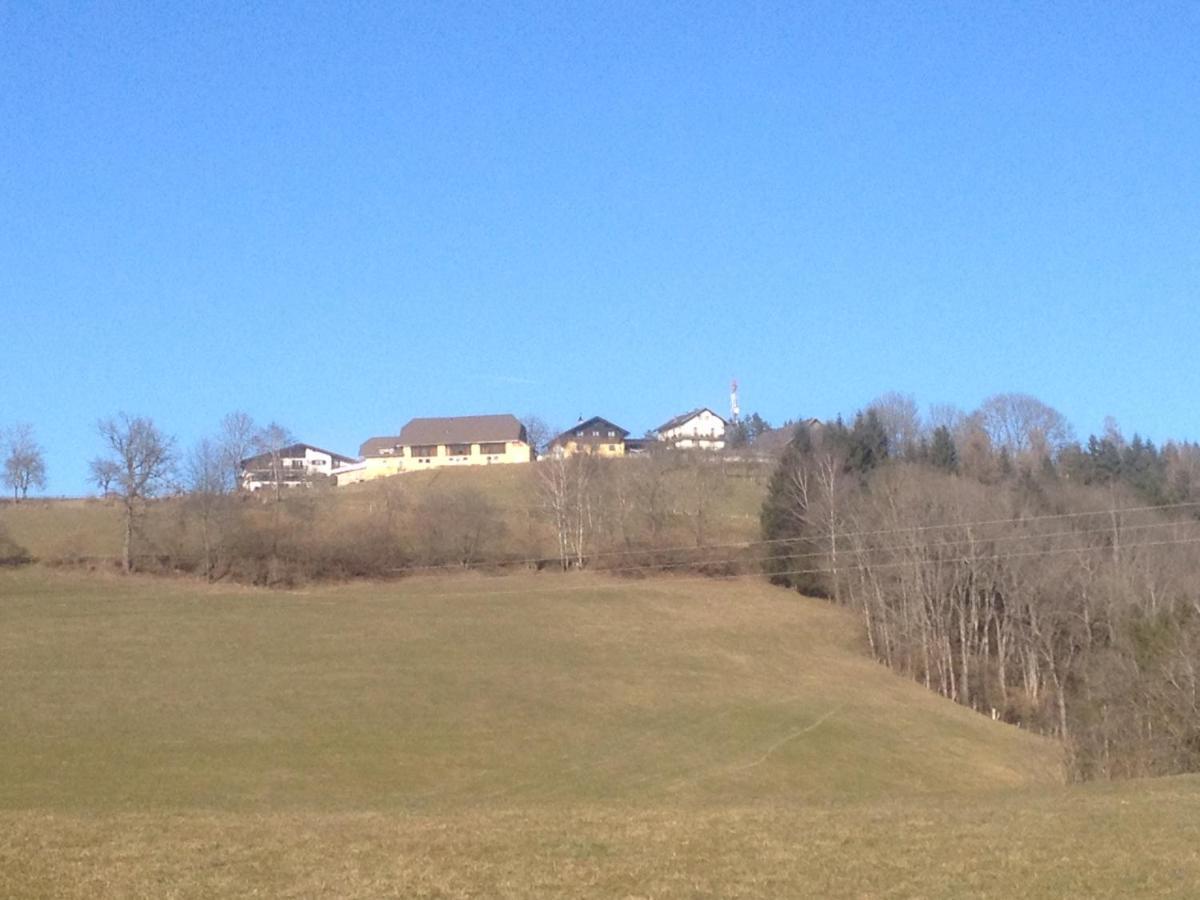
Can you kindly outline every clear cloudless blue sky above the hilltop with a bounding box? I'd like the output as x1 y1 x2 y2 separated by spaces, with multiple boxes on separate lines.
0 0 1200 494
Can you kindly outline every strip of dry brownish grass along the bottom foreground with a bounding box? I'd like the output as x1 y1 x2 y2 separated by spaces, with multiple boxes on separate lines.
0 778 1200 900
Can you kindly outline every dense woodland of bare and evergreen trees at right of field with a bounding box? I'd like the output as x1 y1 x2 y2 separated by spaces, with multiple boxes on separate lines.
762 395 1200 778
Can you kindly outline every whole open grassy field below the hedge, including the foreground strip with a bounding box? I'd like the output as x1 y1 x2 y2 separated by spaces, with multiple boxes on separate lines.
0 568 1200 896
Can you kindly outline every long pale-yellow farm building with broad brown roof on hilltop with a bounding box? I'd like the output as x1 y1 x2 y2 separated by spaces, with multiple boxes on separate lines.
350 414 533 484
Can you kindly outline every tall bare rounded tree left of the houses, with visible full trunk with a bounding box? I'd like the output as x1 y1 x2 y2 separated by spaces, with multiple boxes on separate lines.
91 413 175 574
